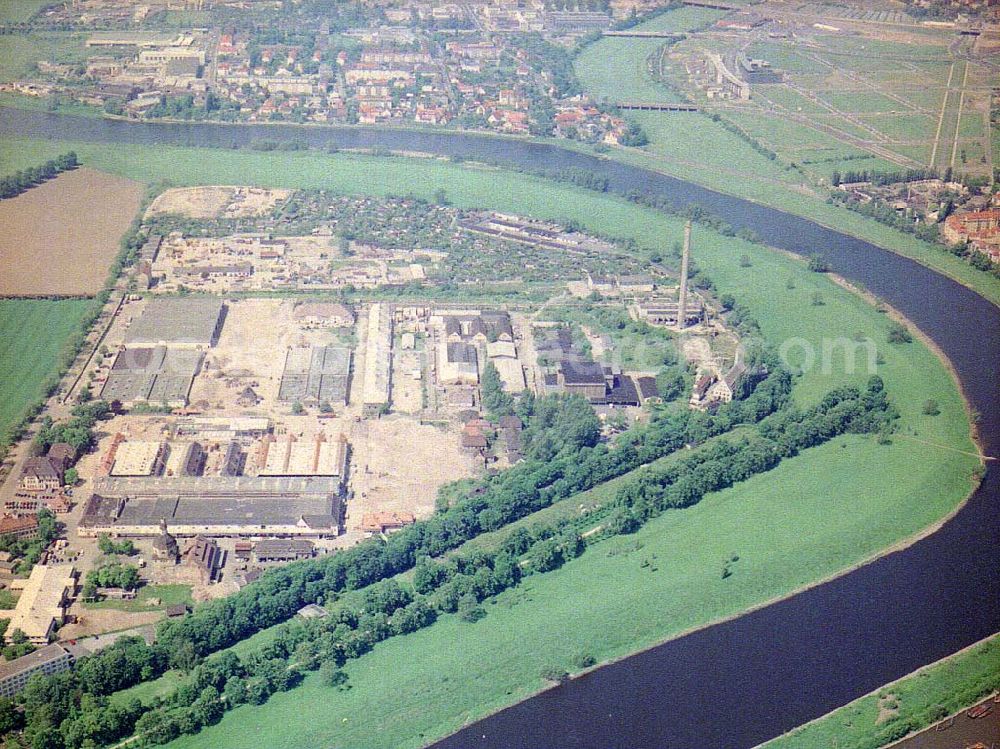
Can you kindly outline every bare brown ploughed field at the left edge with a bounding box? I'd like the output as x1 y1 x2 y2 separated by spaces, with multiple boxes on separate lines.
0 168 143 296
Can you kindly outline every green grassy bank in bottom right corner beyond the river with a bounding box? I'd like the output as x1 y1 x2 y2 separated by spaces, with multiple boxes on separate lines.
764 635 1000 749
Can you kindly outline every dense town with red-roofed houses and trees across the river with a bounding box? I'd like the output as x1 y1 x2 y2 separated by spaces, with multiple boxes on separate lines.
3 0 644 144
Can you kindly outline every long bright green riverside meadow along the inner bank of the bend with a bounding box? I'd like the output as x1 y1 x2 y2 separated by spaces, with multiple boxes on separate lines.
41 146 976 748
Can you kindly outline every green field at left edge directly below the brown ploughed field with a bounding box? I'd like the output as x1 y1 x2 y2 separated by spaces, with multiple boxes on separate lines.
0 299 94 435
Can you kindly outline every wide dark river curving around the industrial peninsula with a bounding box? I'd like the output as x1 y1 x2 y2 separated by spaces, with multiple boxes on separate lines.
0 109 1000 749
